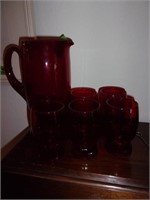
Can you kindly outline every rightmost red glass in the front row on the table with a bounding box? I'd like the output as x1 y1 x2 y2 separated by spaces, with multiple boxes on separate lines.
106 96 139 154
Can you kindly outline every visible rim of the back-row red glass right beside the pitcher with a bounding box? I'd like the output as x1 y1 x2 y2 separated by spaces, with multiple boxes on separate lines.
71 87 98 100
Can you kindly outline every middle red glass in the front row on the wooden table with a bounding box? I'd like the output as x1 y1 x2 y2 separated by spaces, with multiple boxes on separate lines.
69 99 99 158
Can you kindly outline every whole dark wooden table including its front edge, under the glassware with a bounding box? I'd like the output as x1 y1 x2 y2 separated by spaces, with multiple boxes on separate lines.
2 123 149 199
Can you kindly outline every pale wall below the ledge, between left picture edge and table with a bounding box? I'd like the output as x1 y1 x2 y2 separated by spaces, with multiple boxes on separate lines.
1 83 28 147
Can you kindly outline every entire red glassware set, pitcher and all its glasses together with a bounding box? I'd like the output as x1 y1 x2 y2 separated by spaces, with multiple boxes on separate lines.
4 35 138 159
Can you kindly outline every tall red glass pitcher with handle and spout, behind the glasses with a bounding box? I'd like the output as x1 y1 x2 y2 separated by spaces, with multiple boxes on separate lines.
4 36 74 109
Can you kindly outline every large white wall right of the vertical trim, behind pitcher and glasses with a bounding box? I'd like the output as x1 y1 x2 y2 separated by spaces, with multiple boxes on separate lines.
34 1 150 122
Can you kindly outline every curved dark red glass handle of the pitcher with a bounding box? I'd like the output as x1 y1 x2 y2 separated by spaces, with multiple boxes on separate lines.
3 44 26 100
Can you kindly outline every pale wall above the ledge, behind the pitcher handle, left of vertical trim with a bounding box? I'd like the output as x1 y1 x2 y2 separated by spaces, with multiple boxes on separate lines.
0 1 27 78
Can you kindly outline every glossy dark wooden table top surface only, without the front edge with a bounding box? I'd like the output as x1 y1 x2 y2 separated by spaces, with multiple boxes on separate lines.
2 123 149 197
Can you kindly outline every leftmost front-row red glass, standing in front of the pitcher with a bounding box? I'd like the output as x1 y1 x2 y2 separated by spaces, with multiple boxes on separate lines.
30 101 65 159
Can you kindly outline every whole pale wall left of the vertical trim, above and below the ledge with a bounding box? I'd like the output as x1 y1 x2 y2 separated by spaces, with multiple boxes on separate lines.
0 1 28 147
